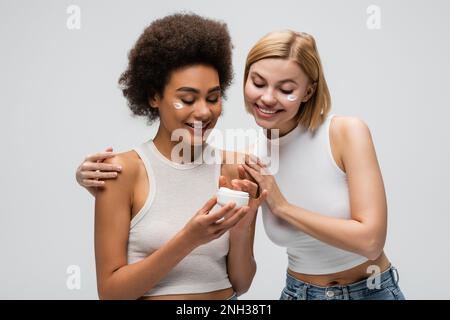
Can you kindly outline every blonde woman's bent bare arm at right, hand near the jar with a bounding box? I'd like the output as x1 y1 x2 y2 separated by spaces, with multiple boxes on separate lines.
244 118 387 260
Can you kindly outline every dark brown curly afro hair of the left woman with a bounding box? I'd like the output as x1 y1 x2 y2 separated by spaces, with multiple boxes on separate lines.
119 13 233 124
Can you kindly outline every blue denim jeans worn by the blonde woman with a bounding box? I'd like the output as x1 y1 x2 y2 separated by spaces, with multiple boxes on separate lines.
280 266 405 300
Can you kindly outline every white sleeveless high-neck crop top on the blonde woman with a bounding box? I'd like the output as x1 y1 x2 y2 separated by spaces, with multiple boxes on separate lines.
254 115 367 275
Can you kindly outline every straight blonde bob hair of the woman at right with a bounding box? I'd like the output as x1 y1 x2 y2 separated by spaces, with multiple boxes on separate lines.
244 30 331 131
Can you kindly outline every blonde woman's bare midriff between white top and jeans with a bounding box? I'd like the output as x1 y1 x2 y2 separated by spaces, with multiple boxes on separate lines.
288 252 390 287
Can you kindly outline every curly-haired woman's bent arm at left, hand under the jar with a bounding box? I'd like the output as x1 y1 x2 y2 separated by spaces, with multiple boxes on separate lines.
95 155 250 299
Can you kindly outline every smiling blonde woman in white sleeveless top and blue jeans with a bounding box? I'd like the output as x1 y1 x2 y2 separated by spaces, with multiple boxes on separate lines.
244 30 404 300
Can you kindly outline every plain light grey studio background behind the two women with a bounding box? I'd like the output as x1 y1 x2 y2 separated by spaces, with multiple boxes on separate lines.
0 0 450 299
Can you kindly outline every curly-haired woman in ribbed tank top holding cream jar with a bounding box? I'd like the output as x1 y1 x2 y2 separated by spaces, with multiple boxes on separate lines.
82 14 266 299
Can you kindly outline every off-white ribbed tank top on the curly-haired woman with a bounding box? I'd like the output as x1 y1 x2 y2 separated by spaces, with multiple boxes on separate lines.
128 140 231 296
